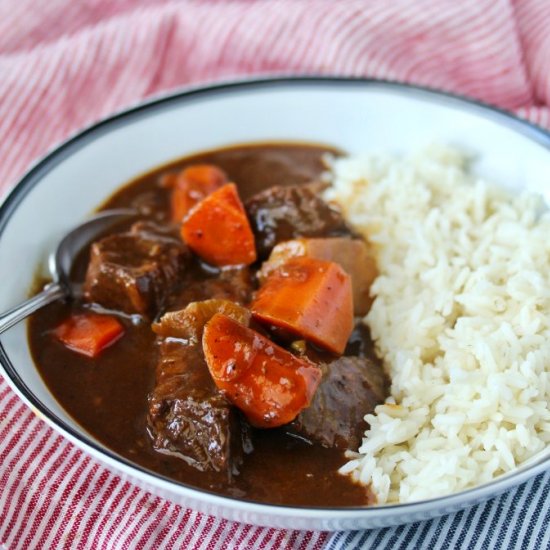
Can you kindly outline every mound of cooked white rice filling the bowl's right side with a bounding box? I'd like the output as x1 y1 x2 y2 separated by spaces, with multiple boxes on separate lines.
326 147 550 503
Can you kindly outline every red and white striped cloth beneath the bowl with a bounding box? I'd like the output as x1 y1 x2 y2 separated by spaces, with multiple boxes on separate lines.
0 0 550 549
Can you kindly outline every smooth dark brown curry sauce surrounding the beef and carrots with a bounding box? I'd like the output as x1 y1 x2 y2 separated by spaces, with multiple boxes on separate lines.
29 144 374 507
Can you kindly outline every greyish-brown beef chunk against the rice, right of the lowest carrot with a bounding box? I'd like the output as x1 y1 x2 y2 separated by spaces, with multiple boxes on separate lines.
288 357 389 450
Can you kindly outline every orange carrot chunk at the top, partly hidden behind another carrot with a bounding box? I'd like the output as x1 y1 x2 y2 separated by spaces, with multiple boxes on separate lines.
169 164 227 223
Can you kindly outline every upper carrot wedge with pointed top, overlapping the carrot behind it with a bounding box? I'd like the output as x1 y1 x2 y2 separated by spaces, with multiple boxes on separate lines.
181 183 256 266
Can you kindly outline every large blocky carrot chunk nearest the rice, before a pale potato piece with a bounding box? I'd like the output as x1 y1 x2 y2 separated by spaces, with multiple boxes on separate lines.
251 257 353 354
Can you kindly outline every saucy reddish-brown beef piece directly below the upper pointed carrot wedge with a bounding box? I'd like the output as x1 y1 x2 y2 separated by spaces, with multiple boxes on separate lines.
167 267 254 310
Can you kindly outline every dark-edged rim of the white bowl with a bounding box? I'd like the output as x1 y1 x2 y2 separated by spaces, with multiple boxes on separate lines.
0 75 550 518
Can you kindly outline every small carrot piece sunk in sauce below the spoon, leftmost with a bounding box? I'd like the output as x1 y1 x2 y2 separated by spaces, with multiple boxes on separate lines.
54 313 124 358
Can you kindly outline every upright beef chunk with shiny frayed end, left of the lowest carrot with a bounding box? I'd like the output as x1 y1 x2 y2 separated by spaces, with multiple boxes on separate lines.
148 339 251 477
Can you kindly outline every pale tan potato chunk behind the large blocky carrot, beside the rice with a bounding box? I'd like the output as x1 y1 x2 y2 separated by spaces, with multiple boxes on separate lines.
258 237 378 315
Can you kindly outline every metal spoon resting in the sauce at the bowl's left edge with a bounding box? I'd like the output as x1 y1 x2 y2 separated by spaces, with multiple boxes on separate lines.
0 208 137 334
